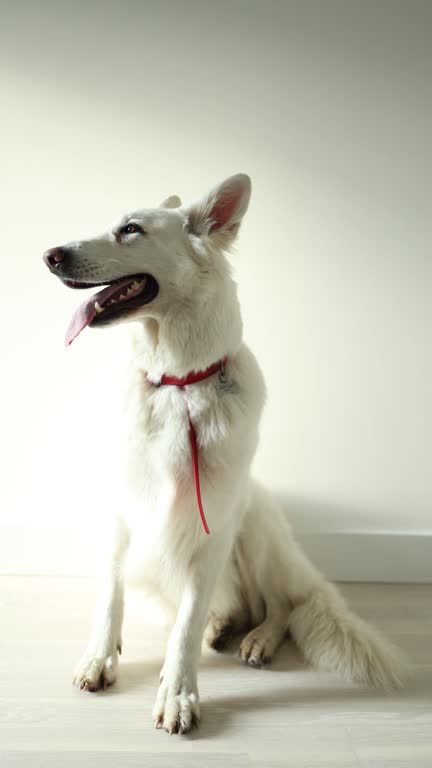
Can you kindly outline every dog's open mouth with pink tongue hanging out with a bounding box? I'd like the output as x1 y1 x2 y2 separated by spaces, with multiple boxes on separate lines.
62 275 159 345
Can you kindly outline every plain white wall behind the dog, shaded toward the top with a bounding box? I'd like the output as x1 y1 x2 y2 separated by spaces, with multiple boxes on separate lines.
0 0 432 575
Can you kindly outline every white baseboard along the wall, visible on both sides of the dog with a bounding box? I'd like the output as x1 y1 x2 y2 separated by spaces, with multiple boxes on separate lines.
0 528 432 584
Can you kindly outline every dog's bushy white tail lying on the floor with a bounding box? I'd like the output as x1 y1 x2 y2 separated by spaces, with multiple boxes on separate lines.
289 579 408 691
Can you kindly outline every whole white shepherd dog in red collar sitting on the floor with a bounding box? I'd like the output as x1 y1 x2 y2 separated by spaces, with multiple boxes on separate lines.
44 174 406 733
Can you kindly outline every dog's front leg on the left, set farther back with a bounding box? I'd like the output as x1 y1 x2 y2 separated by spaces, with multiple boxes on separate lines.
74 520 129 691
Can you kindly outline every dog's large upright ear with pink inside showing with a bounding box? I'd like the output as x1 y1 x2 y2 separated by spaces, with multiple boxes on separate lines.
186 173 251 248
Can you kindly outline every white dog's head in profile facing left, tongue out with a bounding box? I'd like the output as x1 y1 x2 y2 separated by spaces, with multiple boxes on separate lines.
44 174 251 344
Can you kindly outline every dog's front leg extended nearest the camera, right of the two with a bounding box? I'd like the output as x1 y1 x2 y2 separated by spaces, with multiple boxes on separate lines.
153 532 230 734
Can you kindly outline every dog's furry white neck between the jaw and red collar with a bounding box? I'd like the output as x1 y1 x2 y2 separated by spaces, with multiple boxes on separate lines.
133 285 242 381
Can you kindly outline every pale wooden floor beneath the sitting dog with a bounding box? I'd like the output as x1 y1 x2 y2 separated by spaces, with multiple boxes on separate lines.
0 576 432 768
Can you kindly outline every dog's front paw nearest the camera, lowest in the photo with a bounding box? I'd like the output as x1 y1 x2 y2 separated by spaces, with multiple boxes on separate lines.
153 677 200 734
